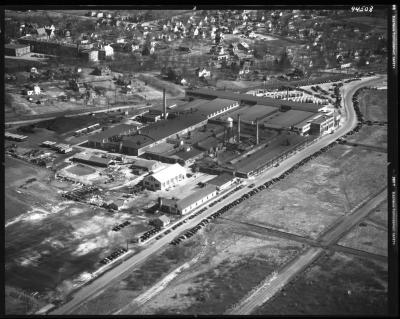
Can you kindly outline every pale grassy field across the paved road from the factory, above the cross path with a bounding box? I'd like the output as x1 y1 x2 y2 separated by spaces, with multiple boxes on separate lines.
226 146 386 238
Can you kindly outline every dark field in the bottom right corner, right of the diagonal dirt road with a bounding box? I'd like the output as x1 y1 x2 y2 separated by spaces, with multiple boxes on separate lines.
254 253 388 315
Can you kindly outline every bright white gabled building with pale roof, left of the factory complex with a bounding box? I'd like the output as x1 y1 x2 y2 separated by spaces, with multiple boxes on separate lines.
143 164 186 191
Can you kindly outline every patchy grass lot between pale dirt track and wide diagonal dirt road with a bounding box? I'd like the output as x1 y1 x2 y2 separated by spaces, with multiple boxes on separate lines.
126 220 303 315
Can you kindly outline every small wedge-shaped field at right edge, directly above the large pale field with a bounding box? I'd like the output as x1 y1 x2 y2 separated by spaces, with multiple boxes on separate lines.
346 125 388 148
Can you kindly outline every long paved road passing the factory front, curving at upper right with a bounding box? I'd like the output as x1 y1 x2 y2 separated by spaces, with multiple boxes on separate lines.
50 77 382 315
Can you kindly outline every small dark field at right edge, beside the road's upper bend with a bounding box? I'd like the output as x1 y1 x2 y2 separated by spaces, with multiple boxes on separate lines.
359 90 388 121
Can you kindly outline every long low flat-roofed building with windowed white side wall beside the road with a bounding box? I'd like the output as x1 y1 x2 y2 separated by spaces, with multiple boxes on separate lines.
159 185 217 215
